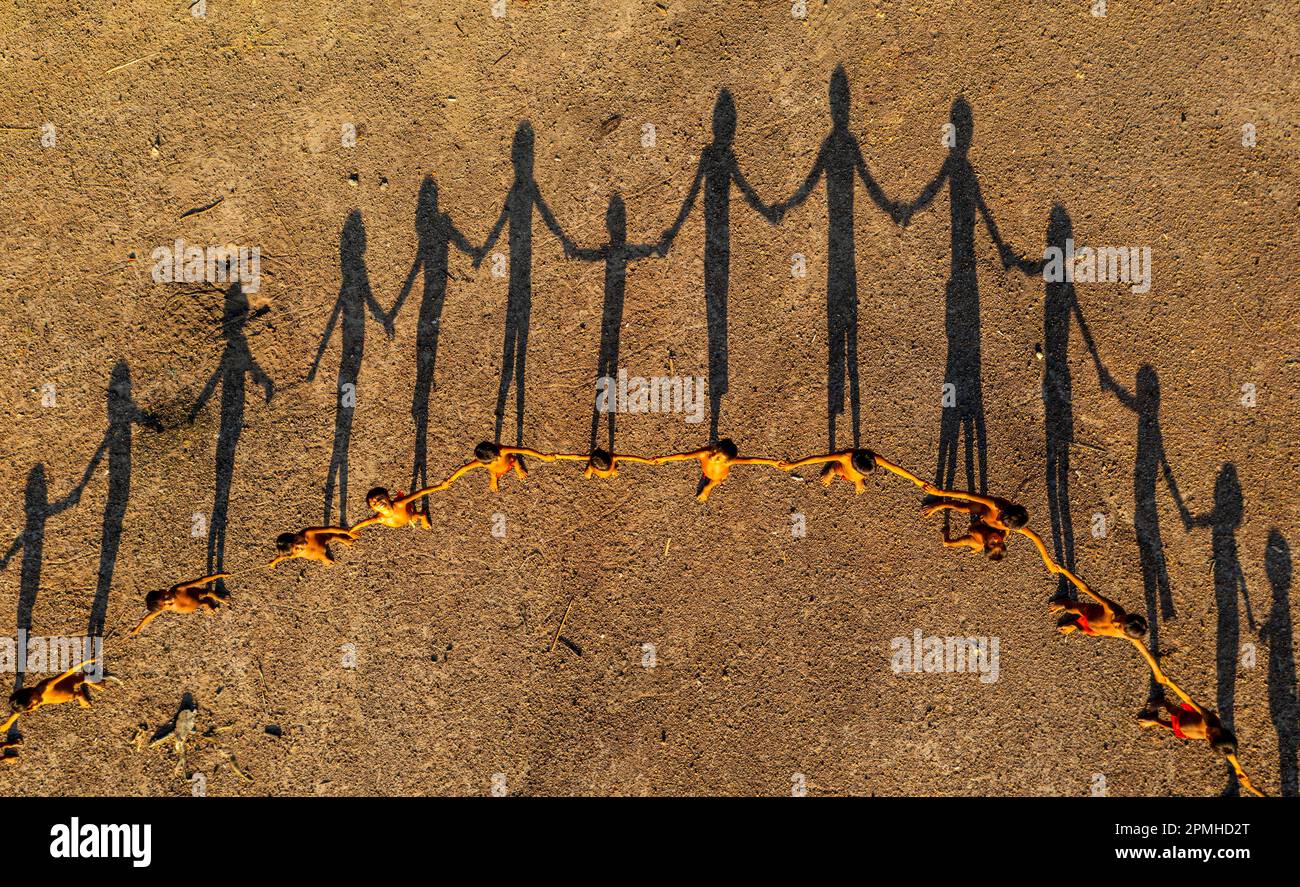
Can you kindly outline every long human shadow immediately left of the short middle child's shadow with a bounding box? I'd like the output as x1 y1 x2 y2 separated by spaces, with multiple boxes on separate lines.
481 121 571 444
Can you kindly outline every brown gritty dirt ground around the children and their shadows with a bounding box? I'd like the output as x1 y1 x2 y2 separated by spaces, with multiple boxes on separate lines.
0 0 1300 796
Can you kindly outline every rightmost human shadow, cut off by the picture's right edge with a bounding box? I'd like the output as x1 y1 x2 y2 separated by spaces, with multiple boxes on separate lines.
1261 527 1300 797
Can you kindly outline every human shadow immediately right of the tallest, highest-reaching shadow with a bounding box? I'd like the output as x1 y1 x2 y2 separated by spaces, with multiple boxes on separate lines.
900 98 1013 493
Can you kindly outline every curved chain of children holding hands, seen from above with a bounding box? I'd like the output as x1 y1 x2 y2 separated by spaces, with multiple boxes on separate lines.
0 440 1264 797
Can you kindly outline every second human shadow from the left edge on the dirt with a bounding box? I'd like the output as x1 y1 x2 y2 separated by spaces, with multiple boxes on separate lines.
86 360 163 637
